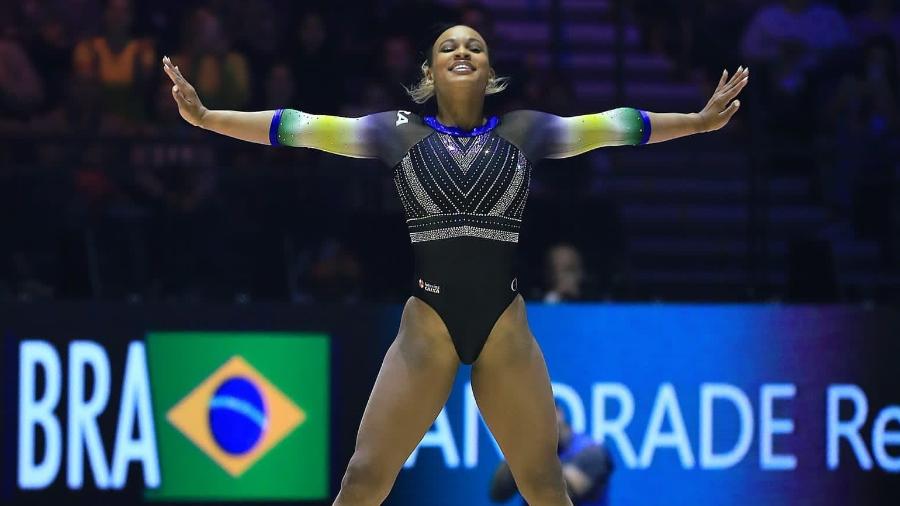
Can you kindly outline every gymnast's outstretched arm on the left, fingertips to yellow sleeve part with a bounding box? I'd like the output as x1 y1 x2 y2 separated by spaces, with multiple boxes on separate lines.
163 57 379 158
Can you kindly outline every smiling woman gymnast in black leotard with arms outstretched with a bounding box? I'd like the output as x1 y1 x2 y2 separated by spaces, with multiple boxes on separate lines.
163 25 749 506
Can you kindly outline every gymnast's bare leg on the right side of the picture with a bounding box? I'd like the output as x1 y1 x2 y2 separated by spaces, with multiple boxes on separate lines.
472 296 572 506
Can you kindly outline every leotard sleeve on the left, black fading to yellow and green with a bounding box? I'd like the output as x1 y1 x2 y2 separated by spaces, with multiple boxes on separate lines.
269 109 423 166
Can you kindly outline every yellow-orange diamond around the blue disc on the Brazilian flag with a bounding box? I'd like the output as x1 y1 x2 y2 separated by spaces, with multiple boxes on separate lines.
166 355 306 478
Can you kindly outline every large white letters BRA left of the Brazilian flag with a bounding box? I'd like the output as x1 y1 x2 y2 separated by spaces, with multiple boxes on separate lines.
17 340 160 490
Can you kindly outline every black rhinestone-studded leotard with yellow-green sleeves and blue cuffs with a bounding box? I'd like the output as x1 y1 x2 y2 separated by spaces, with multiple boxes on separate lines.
271 108 650 364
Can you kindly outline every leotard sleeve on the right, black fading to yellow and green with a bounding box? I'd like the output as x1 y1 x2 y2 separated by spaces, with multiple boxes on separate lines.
502 107 651 162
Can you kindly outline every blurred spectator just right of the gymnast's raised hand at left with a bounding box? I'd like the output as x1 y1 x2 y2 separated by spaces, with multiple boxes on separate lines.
173 8 250 110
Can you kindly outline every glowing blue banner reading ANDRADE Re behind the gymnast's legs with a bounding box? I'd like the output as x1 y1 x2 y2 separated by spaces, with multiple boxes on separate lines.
388 305 900 506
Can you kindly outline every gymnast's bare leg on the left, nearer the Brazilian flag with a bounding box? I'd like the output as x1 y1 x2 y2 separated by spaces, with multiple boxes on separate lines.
334 297 459 506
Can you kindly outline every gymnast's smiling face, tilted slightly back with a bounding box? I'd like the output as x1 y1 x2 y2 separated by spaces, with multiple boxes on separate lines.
426 25 494 99
